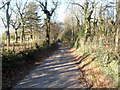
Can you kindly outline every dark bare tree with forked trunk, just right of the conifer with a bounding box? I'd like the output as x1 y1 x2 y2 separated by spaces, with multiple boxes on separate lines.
36 0 58 45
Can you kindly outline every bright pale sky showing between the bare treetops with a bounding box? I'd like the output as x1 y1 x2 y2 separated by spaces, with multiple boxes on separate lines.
0 0 115 34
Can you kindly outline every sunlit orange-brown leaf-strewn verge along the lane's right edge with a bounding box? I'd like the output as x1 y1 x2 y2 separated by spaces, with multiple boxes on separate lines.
71 48 113 88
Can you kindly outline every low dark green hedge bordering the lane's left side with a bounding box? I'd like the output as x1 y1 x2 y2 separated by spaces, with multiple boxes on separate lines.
2 43 57 68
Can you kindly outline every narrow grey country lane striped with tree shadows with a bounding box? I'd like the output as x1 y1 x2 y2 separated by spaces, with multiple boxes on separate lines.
13 46 85 88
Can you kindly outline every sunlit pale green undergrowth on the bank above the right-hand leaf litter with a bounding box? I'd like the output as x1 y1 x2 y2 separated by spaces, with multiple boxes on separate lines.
77 39 120 88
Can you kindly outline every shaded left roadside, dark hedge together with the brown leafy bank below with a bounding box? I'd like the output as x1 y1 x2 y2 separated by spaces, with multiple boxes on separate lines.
2 42 58 90
